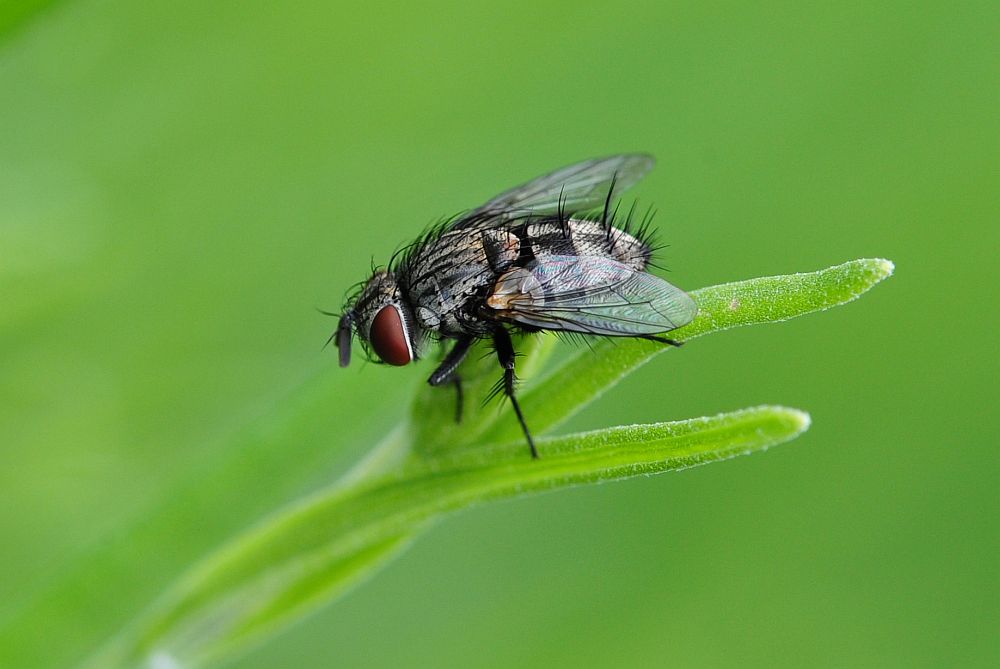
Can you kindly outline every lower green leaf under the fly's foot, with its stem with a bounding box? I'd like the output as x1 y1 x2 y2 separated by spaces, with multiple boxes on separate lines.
84 407 809 667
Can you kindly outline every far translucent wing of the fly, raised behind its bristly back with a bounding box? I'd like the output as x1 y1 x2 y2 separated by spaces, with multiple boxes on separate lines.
452 153 656 230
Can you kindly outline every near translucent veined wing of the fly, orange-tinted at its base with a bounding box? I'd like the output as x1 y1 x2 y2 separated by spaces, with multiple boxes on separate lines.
487 256 698 337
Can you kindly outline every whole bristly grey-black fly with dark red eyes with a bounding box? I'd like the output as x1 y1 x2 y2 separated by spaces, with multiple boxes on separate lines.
331 154 698 458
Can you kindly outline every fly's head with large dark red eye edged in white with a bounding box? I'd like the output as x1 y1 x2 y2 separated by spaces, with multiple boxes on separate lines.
353 270 424 365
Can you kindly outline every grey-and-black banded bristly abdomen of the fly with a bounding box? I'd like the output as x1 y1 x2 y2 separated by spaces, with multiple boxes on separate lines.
525 219 652 271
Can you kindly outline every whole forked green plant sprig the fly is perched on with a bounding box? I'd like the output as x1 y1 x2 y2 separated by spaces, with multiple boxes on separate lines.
80 260 893 668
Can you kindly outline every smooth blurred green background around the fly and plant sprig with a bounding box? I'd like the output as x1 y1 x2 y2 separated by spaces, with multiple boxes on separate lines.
0 0 1000 669
